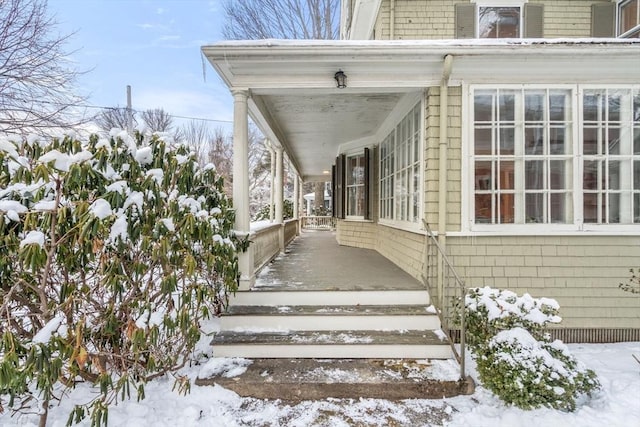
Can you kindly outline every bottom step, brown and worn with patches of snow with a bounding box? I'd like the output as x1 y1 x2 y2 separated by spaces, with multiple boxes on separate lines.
195 359 474 402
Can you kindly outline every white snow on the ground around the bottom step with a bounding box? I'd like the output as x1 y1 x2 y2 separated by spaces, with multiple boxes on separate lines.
0 342 640 427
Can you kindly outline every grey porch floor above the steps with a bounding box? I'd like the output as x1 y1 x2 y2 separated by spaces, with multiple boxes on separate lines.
253 230 425 291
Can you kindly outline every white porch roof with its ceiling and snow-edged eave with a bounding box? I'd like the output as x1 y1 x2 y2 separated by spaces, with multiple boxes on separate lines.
202 39 640 181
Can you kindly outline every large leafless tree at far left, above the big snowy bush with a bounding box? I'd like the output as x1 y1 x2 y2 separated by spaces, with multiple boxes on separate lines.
0 0 90 134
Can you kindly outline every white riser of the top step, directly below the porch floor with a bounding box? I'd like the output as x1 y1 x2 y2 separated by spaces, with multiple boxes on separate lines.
229 288 430 305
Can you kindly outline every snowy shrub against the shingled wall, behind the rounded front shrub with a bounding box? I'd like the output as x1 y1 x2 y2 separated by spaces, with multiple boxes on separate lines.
465 286 562 348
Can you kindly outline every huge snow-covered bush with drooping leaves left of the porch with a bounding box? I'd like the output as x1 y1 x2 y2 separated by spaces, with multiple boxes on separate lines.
0 131 238 424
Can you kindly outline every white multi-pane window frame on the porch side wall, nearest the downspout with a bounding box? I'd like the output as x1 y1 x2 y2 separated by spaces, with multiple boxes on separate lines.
377 96 425 231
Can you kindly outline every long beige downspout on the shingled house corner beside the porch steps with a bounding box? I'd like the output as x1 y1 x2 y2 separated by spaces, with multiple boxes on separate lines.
438 54 453 308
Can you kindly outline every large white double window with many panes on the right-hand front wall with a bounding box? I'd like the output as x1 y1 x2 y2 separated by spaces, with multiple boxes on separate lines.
471 87 640 231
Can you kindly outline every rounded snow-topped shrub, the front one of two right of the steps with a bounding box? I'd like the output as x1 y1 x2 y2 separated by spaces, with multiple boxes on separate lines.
477 328 599 411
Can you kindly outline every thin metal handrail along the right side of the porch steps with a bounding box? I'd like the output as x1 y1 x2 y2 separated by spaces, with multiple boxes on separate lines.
422 220 467 380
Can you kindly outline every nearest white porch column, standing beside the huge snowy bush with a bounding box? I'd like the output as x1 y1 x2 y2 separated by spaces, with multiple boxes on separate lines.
232 90 255 290
